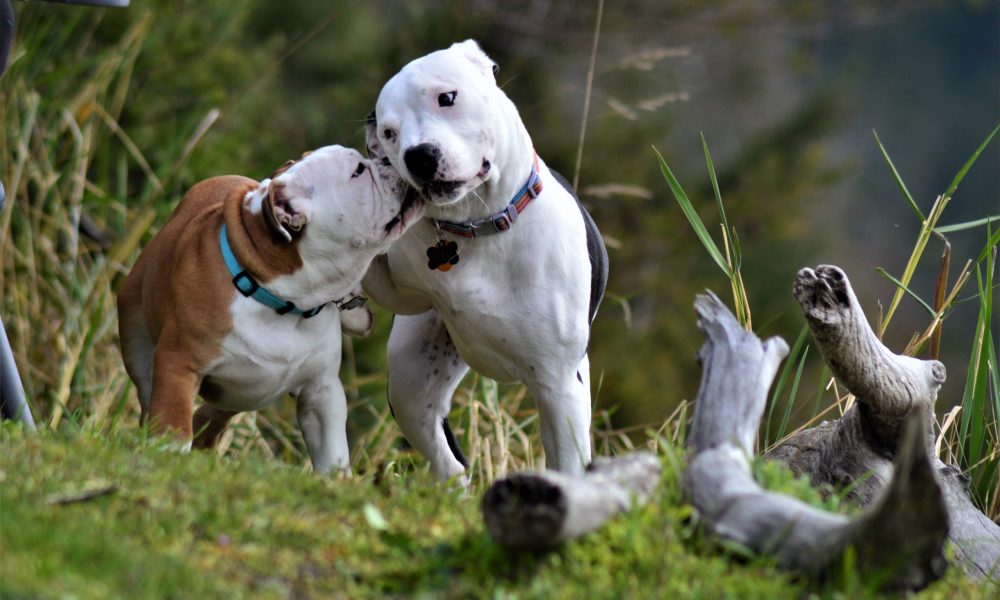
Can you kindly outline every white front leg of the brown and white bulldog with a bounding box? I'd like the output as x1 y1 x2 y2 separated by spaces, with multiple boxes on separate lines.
296 377 351 475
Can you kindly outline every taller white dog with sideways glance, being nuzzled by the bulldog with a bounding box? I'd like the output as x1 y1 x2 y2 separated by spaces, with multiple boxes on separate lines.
363 40 607 480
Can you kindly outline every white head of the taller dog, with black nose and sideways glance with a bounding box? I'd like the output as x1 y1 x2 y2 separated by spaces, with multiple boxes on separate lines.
366 40 517 205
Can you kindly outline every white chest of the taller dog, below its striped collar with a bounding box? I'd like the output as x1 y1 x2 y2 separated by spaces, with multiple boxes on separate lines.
389 218 589 381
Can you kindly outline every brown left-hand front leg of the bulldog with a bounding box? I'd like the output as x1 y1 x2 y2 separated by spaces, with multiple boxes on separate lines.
149 348 200 441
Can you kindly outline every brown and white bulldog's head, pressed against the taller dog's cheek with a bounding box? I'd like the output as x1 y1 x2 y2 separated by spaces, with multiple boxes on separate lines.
259 146 424 254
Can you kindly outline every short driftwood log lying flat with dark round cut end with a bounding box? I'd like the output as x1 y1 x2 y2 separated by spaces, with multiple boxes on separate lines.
482 452 660 550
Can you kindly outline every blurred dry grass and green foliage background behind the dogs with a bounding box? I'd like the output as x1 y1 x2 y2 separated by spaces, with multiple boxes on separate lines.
0 0 1000 446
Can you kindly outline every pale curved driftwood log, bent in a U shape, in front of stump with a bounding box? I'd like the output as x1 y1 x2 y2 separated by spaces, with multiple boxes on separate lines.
682 295 948 589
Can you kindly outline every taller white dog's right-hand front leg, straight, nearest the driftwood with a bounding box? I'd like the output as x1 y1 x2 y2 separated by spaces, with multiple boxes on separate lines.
528 356 591 474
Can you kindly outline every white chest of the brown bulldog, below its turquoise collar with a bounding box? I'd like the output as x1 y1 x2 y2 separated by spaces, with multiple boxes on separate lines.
205 297 341 411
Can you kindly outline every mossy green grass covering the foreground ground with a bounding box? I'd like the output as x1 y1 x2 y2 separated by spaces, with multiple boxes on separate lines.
0 427 991 599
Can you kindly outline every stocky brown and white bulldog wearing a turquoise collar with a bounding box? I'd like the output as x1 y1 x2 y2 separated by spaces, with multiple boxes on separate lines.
118 146 423 473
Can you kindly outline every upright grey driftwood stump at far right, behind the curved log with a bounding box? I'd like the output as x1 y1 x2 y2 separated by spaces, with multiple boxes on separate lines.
768 265 1000 578
